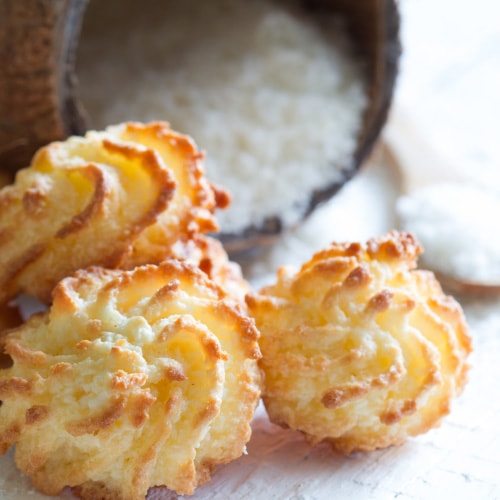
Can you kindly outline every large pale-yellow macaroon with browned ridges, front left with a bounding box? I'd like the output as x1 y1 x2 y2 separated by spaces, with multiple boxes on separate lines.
0 260 260 499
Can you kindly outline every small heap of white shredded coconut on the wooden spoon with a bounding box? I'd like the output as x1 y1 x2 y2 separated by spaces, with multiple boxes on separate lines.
396 183 500 284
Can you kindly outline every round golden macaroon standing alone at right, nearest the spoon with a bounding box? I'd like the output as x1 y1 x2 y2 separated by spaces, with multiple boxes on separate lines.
247 232 471 453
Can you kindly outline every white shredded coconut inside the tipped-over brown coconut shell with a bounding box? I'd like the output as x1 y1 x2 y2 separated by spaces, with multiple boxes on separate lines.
77 0 367 233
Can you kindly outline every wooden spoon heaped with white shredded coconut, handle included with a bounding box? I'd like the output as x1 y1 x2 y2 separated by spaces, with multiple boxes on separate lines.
385 105 500 294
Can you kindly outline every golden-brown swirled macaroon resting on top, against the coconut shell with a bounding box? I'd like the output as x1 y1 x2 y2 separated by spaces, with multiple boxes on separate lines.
0 122 228 303
